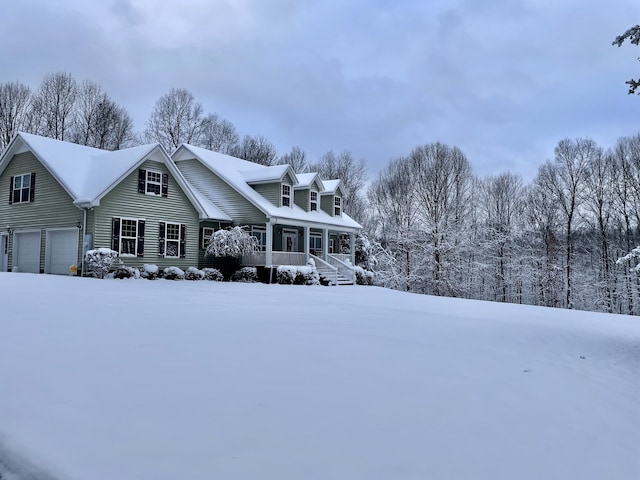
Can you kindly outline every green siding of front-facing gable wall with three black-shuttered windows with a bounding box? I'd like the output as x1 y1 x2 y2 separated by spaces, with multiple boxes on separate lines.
90 160 199 269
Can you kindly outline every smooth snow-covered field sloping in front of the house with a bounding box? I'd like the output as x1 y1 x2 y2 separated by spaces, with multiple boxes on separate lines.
0 273 640 480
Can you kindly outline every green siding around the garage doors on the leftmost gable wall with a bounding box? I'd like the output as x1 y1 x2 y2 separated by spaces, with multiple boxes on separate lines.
0 152 83 272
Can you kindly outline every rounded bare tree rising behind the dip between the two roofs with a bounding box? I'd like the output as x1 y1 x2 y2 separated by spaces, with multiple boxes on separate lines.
144 88 205 153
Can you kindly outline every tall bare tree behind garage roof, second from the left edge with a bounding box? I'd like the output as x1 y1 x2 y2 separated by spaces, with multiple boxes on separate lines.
33 72 78 140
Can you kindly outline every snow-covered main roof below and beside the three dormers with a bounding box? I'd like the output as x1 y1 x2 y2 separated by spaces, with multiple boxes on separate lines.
172 144 362 230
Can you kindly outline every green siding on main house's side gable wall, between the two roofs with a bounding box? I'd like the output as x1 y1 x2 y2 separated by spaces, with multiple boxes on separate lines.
176 159 267 225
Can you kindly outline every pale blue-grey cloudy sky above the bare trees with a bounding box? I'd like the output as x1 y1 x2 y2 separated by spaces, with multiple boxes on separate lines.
0 0 640 178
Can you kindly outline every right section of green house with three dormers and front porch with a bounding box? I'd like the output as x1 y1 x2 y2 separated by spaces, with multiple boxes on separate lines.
172 145 362 284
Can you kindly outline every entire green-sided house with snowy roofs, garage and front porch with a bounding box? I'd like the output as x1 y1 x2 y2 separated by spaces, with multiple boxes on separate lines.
0 133 361 283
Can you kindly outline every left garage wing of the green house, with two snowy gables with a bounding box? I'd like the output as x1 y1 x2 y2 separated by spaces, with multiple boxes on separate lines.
0 133 231 274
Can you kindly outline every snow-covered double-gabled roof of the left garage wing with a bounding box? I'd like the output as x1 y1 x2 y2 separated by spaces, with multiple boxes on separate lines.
0 132 230 220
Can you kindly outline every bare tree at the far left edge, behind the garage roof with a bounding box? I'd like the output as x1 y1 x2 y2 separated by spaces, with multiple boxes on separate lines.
0 82 32 152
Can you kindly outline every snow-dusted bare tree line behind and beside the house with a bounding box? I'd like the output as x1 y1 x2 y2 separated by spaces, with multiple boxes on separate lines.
0 73 640 314
